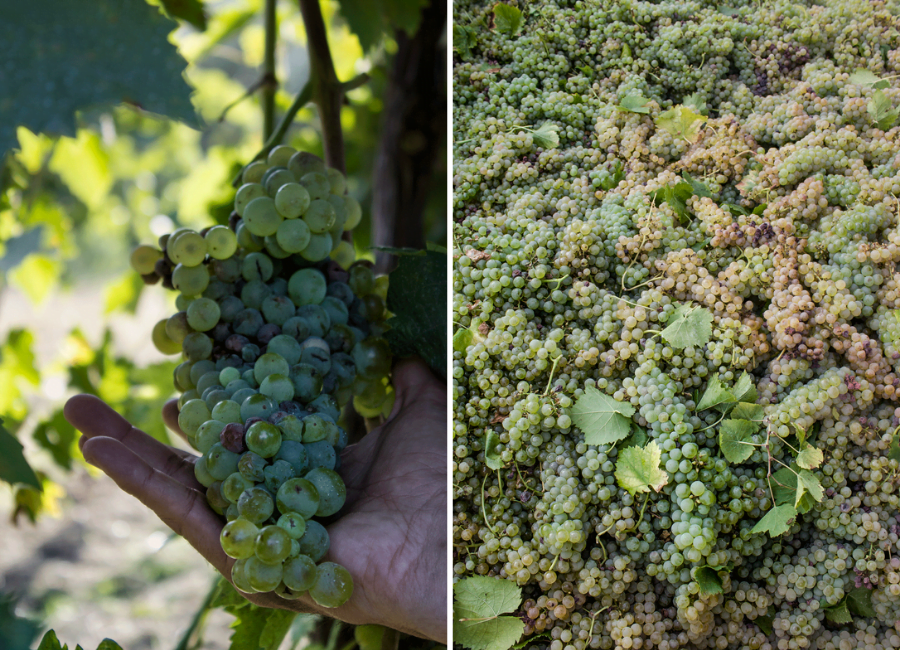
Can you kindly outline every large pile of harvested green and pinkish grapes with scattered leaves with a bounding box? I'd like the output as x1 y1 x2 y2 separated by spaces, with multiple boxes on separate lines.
452 0 900 650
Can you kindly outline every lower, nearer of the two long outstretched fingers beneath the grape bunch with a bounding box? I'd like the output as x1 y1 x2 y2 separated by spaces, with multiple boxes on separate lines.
83 436 231 577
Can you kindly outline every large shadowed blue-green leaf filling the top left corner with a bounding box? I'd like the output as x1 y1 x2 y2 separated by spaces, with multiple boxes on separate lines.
0 0 197 156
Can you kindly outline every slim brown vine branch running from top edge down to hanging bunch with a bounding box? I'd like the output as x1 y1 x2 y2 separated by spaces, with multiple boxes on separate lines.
298 0 347 173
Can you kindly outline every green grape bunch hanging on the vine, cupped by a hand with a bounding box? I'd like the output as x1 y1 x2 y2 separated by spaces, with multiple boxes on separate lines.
131 146 393 607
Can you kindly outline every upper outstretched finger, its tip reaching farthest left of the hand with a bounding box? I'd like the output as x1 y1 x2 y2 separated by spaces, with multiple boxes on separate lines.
63 395 202 489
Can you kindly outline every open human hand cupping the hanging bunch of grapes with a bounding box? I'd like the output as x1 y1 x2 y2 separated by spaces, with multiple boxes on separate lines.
65 359 447 643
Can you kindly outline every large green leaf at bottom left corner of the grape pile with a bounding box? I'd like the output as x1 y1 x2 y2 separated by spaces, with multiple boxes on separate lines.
453 576 525 650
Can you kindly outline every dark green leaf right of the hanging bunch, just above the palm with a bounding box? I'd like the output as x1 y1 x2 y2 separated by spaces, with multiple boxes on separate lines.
385 251 447 376
